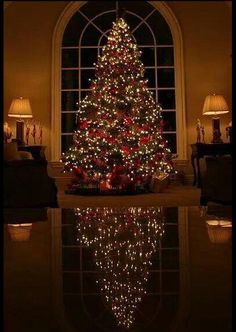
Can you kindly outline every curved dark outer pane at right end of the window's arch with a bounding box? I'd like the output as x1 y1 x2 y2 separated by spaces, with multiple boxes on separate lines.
147 10 173 45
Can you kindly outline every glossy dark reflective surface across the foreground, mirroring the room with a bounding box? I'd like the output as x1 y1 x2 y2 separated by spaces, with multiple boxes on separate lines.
4 206 232 332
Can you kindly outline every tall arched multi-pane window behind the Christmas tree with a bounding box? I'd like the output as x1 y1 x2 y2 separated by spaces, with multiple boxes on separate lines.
52 1 185 160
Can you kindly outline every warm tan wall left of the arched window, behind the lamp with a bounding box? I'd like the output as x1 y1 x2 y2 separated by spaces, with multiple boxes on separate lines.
4 1 68 158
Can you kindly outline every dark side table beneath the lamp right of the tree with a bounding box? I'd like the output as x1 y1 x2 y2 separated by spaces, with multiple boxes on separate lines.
191 143 232 188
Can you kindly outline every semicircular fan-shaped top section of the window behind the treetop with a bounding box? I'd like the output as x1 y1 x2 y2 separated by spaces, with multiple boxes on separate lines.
62 1 173 47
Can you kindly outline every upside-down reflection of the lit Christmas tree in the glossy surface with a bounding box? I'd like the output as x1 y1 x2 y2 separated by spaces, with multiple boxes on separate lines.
75 208 164 328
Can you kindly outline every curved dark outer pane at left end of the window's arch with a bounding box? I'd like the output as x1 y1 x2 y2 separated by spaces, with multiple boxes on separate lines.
62 12 87 46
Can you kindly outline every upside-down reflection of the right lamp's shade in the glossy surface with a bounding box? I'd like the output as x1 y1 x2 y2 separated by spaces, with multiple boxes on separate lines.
206 220 232 243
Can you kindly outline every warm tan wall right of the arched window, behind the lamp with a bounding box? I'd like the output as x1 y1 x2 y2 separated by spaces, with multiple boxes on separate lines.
167 1 232 169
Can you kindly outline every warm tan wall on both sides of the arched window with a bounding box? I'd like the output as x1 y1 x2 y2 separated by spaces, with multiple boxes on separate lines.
4 1 232 172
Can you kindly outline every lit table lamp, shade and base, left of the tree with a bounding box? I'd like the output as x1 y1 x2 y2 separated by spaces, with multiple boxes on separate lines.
8 97 33 144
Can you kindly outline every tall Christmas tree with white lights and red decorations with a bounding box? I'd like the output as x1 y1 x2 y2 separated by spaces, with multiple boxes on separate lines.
61 18 172 190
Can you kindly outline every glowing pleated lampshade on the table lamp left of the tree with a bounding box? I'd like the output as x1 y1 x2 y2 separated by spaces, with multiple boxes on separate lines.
8 97 33 118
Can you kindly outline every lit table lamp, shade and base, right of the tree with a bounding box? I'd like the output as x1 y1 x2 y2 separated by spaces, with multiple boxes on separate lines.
202 94 229 143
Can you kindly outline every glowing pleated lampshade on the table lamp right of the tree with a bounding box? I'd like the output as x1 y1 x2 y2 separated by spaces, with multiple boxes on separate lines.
202 94 229 115
